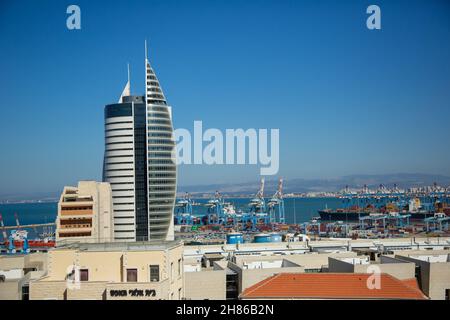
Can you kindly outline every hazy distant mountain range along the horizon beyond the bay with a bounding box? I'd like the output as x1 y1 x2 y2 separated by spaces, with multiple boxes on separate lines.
0 173 450 203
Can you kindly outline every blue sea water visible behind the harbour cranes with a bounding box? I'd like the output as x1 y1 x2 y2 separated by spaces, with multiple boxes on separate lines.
0 198 341 226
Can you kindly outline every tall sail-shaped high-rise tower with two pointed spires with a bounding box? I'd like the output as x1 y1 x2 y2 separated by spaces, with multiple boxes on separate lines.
103 45 177 241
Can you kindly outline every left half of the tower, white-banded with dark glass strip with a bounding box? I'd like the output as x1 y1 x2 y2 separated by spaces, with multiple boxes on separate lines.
103 95 148 241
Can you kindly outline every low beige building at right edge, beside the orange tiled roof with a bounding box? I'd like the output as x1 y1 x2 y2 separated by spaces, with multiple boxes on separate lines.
395 250 450 300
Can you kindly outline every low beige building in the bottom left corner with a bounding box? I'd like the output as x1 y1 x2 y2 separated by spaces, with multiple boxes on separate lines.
0 253 47 300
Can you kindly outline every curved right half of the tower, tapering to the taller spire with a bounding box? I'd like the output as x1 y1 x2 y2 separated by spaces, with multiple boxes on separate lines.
145 58 177 240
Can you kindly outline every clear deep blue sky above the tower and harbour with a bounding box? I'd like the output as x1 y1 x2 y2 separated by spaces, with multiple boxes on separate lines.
0 0 450 194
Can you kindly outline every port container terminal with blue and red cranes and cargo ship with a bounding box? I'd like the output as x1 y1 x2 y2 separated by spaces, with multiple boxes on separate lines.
0 179 450 253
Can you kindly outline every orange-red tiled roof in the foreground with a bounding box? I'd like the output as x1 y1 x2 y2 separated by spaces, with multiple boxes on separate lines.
241 273 427 300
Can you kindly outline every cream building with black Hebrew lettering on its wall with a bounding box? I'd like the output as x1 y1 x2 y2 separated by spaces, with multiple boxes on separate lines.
30 241 184 300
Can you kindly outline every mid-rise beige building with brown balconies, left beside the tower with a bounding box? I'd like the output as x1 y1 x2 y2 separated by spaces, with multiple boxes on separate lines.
56 181 114 246
